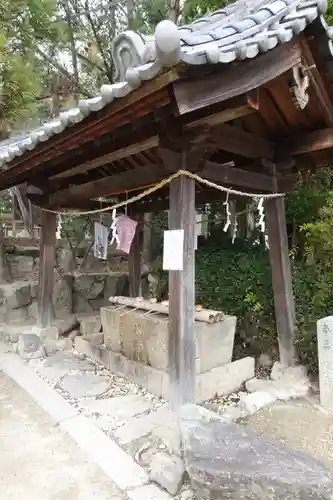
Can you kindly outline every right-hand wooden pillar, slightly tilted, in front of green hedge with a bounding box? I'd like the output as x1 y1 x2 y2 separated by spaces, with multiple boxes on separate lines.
266 197 296 366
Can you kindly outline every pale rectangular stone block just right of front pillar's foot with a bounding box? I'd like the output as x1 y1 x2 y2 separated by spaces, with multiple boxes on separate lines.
196 357 255 403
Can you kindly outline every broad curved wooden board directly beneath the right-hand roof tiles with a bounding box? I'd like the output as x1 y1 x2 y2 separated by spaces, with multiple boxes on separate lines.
173 40 302 115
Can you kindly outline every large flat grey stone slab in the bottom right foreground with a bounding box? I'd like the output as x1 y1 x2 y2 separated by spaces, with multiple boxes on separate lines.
180 405 333 500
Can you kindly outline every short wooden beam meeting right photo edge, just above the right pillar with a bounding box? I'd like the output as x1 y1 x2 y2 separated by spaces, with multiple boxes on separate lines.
276 128 333 157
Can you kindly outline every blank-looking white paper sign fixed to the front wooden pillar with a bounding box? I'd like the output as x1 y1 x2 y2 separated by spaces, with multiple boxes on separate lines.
163 229 184 271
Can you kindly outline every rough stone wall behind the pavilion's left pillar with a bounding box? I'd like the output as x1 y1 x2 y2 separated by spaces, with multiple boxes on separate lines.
0 244 128 322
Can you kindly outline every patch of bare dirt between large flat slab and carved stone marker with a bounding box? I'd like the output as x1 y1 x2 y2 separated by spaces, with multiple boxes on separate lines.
245 400 333 470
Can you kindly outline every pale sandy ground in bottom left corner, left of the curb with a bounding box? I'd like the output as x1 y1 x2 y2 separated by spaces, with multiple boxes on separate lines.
0 371 126 500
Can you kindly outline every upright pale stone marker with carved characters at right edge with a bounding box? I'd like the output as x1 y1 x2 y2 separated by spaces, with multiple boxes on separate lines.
317 316 333 413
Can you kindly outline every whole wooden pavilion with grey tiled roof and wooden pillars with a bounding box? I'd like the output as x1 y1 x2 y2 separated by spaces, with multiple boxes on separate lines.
0 0 333 401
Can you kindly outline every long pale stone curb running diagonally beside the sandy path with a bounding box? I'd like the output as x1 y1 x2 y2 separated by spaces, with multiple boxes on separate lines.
0 342 171 500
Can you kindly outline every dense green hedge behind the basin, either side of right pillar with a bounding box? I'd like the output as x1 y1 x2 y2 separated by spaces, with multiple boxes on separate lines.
196 236 333 371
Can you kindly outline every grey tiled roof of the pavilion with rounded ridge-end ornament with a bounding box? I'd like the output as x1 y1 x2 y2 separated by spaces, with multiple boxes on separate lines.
0 0 333 168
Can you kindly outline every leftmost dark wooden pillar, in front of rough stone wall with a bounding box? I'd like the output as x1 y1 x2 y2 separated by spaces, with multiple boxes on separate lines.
38 210 57 328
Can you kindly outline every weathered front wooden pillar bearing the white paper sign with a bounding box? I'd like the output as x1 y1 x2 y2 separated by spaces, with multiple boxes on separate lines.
169 176 196 407
